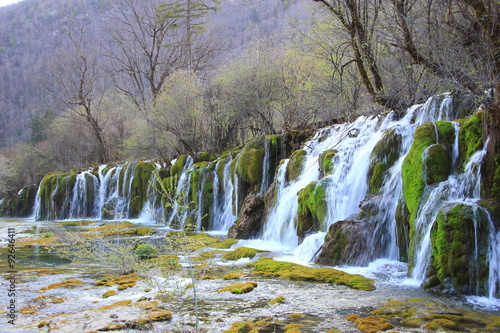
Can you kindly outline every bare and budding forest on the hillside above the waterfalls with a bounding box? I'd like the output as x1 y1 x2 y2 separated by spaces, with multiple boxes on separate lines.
0 0 500 195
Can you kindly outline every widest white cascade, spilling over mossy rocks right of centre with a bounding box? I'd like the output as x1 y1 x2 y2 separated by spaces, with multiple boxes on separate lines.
268 96 454 261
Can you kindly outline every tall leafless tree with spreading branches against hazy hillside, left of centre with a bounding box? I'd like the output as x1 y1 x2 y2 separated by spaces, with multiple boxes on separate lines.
104 0 221 111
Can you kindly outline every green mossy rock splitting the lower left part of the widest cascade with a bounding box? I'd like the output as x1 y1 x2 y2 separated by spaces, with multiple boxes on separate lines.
297 180 328 239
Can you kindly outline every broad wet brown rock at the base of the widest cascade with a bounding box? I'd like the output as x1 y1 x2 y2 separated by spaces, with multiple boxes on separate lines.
316 219 373 266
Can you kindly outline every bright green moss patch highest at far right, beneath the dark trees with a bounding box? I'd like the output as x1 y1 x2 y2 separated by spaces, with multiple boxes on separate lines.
458 111 484 166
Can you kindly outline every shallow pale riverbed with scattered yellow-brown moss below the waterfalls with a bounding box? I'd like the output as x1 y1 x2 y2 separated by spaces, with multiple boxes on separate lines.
0 219 500 332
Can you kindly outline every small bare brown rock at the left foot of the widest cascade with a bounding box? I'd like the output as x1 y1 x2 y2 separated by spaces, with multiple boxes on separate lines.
228 193 264 239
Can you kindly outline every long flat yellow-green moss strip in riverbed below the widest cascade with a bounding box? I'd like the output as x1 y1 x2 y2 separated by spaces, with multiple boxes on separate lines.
253 258 375 291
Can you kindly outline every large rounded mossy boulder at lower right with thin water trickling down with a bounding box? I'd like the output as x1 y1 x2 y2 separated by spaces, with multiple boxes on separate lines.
429 204 489 294
